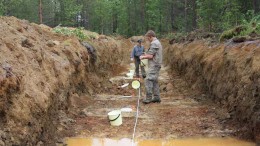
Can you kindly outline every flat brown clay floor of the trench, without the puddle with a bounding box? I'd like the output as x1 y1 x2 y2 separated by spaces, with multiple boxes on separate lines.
59 64 239 139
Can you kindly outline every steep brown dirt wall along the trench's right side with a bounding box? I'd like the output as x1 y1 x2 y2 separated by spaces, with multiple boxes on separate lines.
164 40 260 141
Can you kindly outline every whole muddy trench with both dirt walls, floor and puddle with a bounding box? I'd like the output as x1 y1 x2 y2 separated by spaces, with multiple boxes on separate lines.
0 17 260 146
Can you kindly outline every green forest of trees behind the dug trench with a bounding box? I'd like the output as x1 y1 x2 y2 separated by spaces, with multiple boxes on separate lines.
0 0 260 36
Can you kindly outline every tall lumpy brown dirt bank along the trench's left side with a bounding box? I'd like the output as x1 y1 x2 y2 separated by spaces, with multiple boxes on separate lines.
0 17 128 145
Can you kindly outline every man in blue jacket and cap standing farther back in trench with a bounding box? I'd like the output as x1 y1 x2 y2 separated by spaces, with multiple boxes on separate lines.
131 40 146 78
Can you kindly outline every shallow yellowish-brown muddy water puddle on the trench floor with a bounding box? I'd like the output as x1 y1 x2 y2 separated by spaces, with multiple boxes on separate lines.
66 138 256 146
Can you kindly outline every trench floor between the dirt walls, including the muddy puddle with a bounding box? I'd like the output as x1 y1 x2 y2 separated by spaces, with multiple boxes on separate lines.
54 40 256 146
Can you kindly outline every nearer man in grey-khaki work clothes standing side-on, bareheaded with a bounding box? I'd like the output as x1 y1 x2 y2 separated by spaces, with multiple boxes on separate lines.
140 30 162 104
